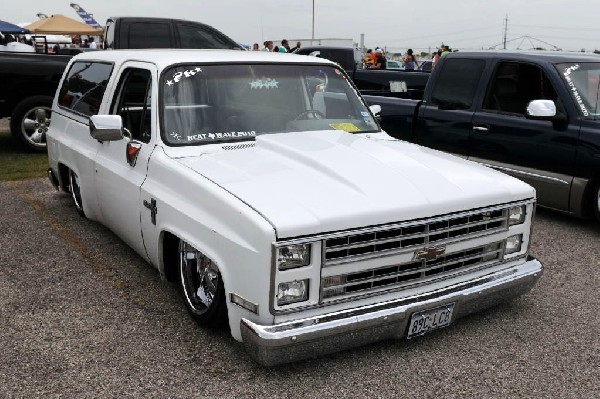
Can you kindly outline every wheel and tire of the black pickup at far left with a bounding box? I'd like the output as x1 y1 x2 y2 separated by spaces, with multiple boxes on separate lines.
10 96 52 152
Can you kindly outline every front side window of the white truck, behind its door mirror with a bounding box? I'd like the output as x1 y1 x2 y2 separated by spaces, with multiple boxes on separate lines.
111 68 152 143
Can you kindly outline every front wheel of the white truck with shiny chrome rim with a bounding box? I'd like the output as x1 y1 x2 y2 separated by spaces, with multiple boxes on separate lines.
178 240 227 327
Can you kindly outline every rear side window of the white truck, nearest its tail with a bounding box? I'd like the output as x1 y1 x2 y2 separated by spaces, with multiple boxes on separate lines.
58 61 113 116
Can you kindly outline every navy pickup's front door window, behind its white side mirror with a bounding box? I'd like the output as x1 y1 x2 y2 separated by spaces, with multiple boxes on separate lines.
483 62 559 115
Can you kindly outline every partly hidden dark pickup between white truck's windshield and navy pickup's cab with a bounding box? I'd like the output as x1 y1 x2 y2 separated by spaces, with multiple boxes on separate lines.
294 46 430 99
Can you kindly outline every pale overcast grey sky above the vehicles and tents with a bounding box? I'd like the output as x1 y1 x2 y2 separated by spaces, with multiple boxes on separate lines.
0 0 600 52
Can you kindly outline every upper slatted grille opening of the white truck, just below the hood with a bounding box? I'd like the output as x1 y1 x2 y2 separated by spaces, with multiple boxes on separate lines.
323 209 508 266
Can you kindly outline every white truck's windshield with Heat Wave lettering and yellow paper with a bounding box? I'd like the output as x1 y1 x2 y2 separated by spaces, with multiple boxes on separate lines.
161 64 379 145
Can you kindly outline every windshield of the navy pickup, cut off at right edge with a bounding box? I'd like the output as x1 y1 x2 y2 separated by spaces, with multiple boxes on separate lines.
556 62 600 119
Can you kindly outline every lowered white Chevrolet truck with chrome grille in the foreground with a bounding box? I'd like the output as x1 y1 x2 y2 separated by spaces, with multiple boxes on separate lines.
47 50 542 365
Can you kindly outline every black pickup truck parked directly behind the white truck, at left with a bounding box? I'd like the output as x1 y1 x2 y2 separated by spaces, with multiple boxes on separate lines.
0 17 243 151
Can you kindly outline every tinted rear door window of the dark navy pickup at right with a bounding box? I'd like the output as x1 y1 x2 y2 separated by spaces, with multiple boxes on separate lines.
431 58 485 109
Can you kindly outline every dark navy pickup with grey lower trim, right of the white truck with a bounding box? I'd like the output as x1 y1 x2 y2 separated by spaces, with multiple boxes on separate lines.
366 51 600 219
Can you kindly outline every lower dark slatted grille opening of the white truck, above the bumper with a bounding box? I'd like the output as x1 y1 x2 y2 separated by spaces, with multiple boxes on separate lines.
321 241 505 300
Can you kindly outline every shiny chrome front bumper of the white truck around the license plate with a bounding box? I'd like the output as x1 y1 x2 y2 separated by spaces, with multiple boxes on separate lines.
240 257 543 366
